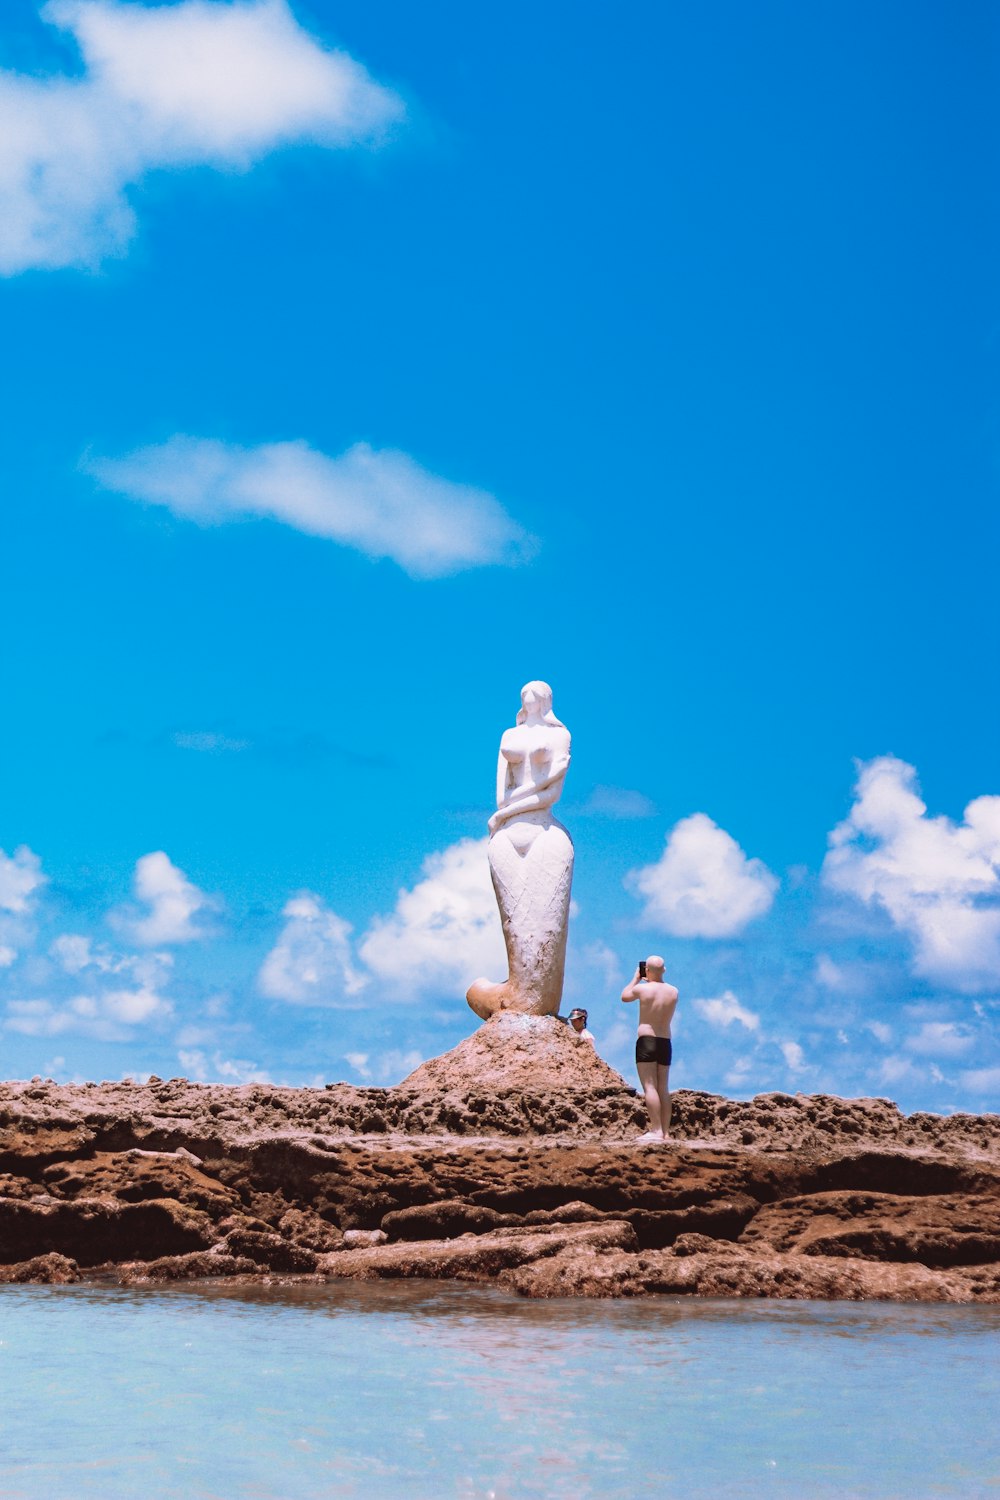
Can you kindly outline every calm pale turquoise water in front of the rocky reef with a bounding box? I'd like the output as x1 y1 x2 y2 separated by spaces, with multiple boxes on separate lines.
0 1283 1000 1500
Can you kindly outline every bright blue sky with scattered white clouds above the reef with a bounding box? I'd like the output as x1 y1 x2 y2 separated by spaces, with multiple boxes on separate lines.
0 0 1000 1110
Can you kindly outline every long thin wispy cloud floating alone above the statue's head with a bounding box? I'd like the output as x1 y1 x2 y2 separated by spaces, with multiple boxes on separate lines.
84 435 535 578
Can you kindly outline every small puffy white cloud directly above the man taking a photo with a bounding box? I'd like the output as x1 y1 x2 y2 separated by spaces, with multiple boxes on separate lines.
625 813 778 938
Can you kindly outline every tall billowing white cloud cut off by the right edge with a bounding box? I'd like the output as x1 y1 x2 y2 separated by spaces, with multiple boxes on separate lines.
823 756 1000 990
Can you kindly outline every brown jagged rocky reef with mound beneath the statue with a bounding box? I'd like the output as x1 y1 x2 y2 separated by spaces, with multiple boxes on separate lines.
0 1016 1000 1302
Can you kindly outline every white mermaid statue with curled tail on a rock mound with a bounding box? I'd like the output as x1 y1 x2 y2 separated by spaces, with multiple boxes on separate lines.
466 683 573 1020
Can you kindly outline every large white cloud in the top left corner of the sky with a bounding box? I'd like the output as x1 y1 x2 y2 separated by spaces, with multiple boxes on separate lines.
0 0 403 275
